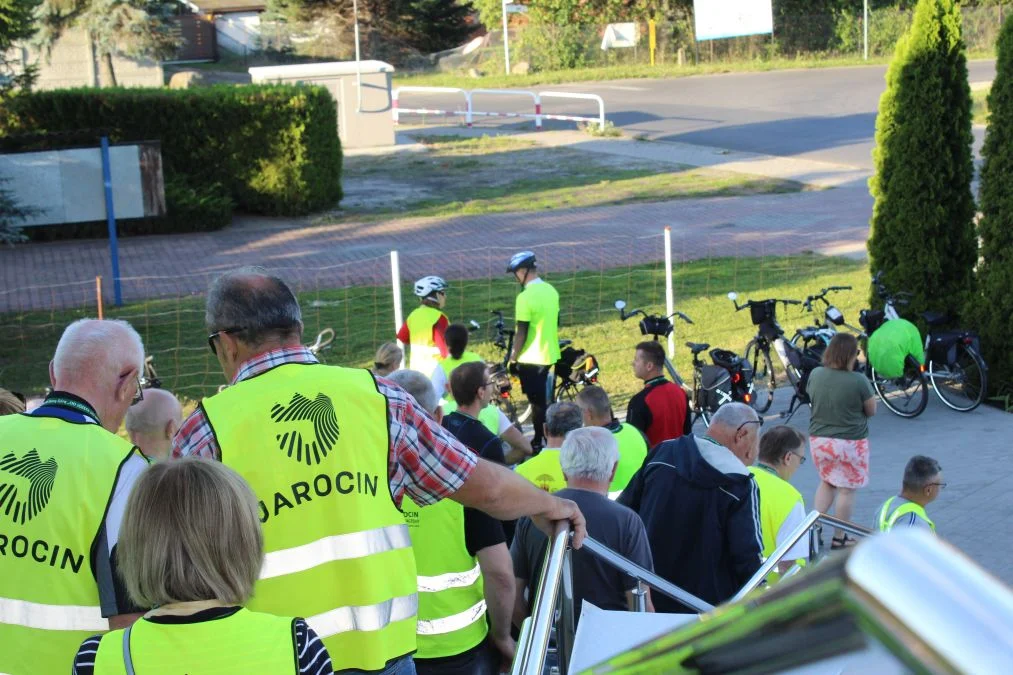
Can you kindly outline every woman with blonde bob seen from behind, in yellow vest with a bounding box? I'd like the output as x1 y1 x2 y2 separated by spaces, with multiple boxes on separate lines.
73 458 332 675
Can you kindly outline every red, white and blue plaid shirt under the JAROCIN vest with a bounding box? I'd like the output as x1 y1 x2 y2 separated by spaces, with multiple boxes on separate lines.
172 347 478 507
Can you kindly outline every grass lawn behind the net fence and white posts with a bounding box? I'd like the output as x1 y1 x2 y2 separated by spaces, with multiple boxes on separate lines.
0 254 869 402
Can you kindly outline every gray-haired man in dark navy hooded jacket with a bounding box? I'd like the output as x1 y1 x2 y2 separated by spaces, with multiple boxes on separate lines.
618 403 763 612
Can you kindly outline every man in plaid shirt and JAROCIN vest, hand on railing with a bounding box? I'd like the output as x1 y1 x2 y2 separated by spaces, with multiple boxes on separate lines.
172 268 586 675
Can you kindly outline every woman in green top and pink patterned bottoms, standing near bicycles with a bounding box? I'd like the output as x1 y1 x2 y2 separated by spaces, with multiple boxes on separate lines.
806 332 876 548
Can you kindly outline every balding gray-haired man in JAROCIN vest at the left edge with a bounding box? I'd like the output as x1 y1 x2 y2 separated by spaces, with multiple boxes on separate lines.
0 319 147 673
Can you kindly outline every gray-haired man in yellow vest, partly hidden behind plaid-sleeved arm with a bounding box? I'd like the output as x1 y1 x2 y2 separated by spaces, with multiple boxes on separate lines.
391 370 517 675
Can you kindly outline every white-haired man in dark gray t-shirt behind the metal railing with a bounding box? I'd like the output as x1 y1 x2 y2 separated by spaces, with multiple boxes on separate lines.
511 427 654 624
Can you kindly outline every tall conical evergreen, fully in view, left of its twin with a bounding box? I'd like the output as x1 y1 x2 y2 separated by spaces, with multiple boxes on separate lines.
868 0 978 324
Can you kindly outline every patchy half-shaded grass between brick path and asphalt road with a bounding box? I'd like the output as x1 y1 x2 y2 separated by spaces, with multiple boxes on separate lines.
336 135 807 220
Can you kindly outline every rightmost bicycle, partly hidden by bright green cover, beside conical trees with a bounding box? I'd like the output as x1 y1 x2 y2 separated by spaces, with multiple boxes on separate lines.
863 272 989 413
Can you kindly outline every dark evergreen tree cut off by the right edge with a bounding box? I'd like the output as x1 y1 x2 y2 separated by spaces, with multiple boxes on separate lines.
966 13 1013 393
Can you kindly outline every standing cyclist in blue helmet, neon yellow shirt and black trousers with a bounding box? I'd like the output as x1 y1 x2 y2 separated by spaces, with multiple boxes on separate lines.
507 250 559 451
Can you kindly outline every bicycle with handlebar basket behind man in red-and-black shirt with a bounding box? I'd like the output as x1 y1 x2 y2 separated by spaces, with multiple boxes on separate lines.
615 300 753 425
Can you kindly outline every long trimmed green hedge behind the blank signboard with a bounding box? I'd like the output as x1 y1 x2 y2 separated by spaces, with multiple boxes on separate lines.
0 85 341 231
